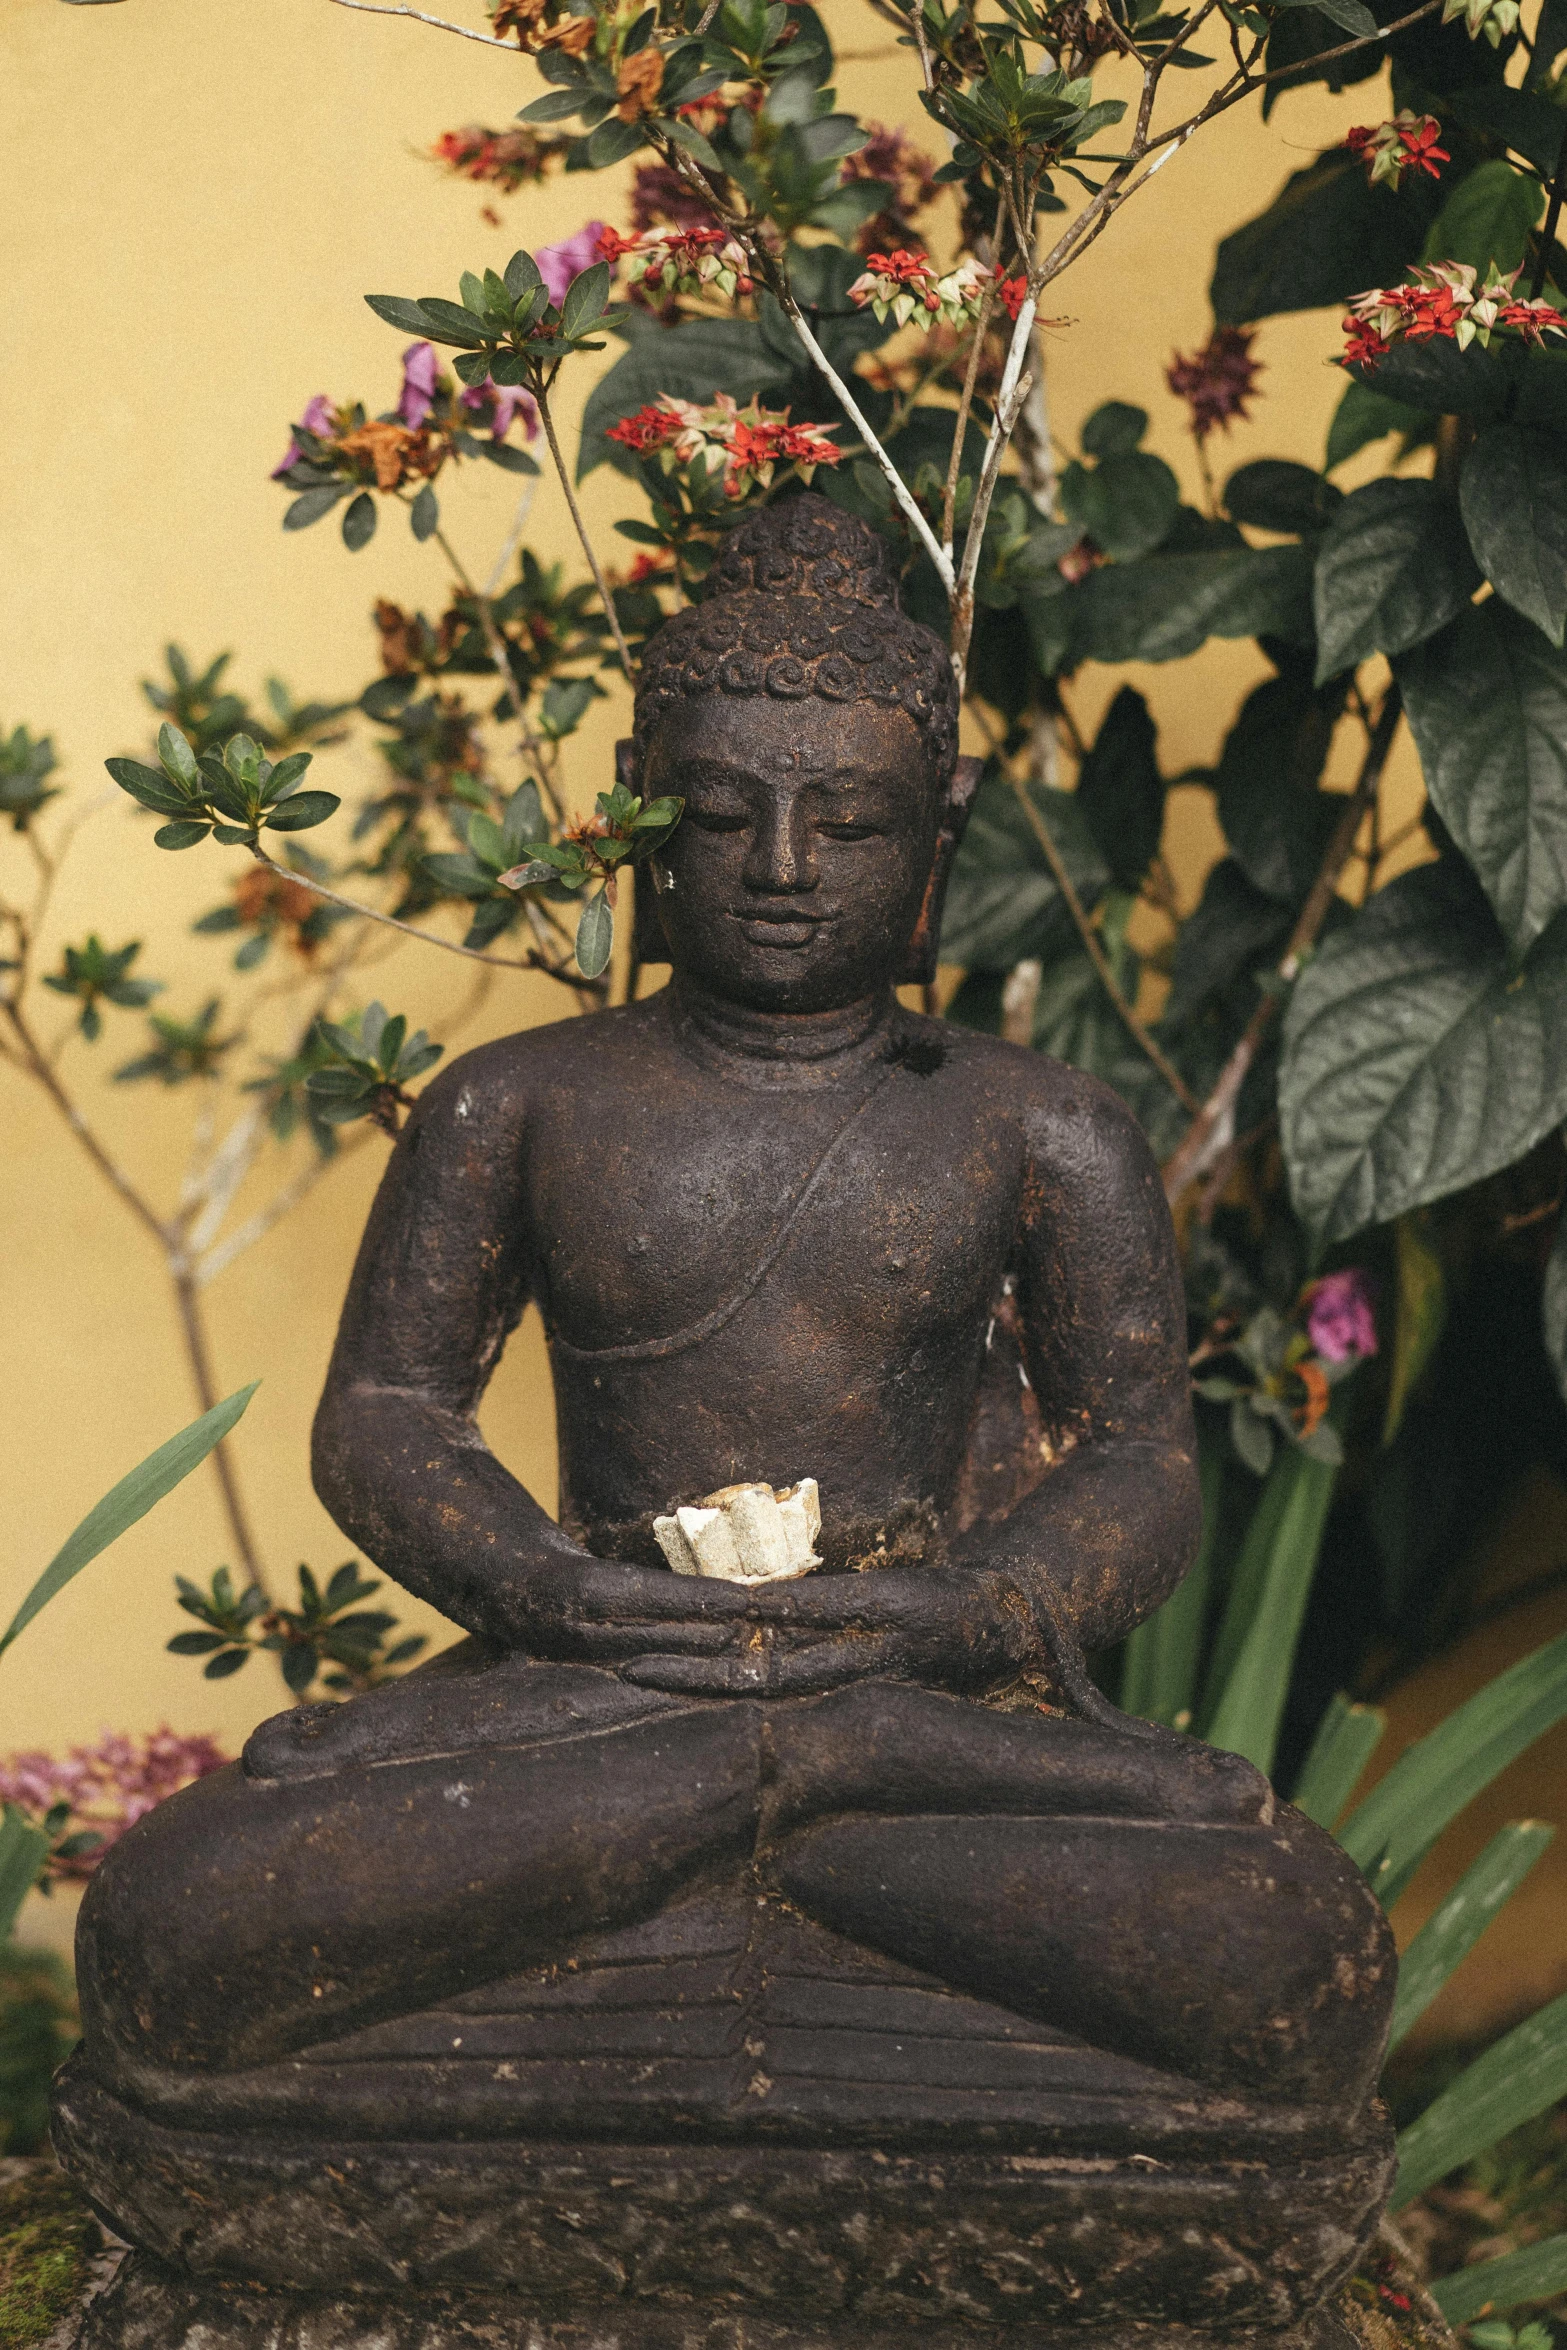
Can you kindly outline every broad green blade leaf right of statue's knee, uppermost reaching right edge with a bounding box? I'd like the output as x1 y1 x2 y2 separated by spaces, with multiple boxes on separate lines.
1339 1633 1567 1908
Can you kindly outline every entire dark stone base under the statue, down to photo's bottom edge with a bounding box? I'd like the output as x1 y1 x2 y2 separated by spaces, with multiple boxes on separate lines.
54 2059 1391 2350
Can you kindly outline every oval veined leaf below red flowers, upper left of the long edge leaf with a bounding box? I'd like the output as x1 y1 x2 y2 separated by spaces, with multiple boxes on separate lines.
1313 479 1480 684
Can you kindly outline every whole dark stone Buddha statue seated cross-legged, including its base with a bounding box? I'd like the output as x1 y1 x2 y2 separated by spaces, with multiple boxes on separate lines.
56 496 1393 2350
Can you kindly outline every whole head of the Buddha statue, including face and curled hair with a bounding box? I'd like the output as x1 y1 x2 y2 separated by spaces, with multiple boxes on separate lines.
623 496 977 1011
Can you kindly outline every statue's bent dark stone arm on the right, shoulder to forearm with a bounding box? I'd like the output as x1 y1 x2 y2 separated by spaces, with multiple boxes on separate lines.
966 1065 1201 1647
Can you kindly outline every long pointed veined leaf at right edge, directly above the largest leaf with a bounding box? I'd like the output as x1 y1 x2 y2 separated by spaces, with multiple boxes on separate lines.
1395 599 1567 954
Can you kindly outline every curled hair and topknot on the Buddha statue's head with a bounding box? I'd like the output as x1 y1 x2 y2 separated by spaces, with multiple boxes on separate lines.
634 491 959 783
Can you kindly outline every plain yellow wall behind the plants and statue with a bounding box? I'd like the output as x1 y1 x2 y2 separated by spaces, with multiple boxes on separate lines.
0 0 1503 1983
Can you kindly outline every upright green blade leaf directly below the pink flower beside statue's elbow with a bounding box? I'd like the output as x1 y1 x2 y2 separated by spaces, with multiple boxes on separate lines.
1203 1445 1339 1772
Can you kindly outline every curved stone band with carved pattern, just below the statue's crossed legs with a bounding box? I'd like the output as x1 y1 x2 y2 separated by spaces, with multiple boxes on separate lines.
56 2084 1388 2334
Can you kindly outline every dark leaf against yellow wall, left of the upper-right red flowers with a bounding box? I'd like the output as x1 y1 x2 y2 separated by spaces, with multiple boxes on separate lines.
1210 148 1440 327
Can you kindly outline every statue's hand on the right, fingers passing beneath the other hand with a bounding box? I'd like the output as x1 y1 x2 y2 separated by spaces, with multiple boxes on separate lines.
625 1567 1034 1697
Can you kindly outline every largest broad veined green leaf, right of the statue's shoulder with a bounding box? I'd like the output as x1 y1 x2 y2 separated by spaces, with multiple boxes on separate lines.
1278 860 1567 1248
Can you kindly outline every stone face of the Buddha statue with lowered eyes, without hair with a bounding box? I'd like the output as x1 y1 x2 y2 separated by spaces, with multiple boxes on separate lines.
639 693 940 1013
